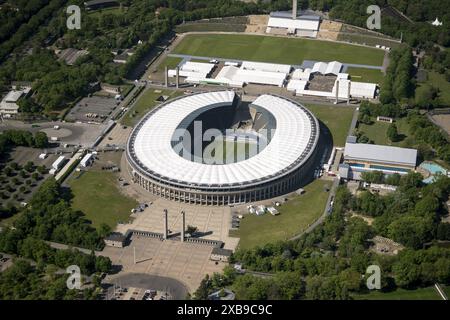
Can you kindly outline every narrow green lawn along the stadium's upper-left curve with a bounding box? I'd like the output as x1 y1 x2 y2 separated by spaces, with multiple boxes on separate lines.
120 89 183 126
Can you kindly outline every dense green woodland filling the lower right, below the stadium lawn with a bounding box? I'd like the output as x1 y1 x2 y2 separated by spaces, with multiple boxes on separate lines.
194 173 450 299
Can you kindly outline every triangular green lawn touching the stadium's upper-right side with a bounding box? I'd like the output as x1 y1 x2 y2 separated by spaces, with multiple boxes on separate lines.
306 104 355 147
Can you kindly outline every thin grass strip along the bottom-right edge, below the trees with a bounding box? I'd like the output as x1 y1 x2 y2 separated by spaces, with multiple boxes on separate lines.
353 287 442 300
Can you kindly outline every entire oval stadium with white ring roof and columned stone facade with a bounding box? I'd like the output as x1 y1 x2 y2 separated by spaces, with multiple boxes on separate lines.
126 91 320 206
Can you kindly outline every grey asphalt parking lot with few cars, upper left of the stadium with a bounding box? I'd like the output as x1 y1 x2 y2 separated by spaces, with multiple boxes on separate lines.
66 96 119 123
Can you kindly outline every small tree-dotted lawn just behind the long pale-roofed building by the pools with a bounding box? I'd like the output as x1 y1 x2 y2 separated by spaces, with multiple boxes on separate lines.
358 118 408 146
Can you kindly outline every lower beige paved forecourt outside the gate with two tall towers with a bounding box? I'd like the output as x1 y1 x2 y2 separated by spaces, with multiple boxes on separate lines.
102 235 226 299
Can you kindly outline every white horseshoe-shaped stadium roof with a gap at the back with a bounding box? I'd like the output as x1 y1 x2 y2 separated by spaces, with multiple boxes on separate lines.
128 91 319 187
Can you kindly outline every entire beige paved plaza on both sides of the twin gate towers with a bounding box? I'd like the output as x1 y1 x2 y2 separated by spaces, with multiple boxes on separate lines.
101 156 239 298
